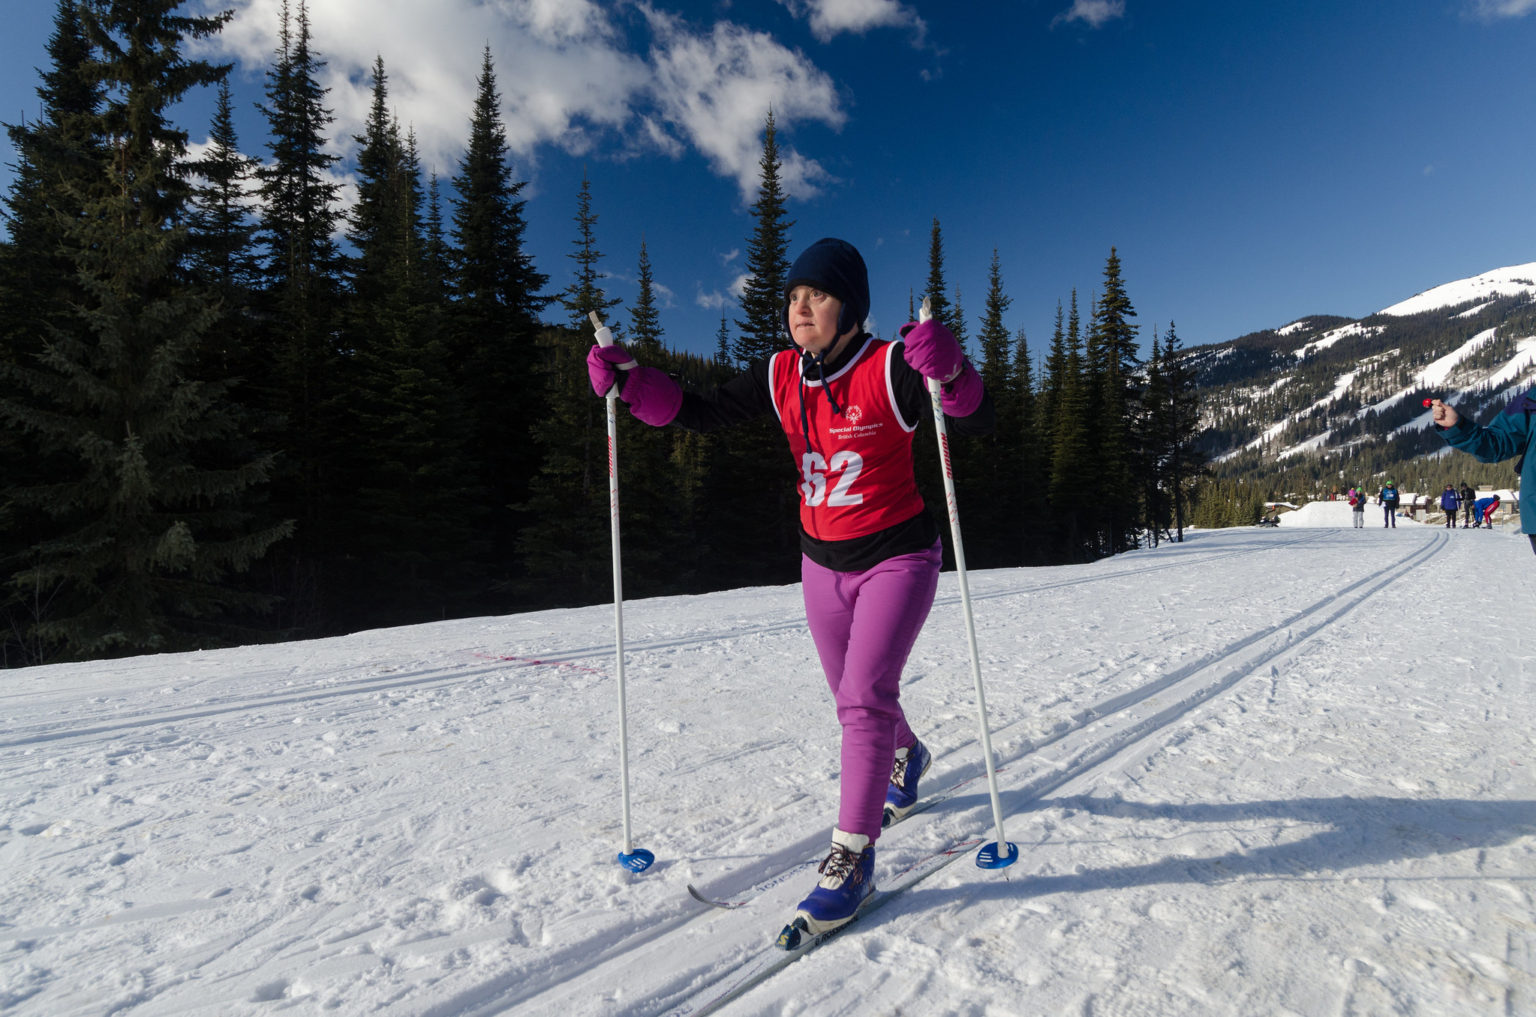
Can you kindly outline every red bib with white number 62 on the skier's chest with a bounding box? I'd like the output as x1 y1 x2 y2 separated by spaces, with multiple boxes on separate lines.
768 340 923 541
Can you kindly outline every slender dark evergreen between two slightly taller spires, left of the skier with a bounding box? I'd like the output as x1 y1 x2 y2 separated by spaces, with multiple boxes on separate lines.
336 60 485 625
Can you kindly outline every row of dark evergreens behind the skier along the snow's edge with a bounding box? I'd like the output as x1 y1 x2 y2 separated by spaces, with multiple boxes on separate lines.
0 0 1201 667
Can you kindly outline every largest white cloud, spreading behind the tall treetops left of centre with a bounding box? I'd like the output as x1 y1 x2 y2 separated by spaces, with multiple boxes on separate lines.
204 0 847 200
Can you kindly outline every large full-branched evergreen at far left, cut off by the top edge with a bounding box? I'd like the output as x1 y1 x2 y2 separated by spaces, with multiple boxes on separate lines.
0 0 289 658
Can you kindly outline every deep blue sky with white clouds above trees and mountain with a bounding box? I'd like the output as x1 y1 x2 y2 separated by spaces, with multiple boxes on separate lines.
0 0 1536 362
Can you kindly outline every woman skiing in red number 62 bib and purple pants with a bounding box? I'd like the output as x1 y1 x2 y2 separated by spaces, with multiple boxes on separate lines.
587 238 994 934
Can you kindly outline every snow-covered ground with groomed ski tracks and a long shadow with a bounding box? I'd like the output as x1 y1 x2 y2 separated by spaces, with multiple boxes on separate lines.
0 502 1536 1017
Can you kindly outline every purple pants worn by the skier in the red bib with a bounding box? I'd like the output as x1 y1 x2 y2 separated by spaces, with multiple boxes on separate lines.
800 542 940 843
